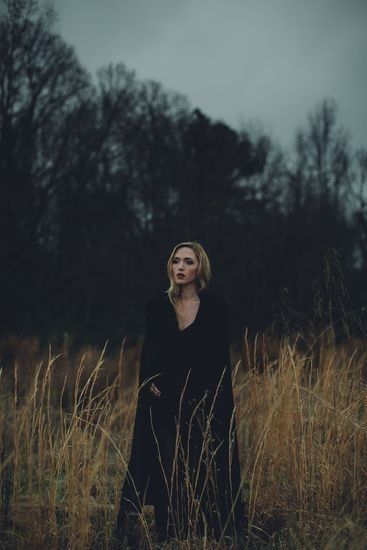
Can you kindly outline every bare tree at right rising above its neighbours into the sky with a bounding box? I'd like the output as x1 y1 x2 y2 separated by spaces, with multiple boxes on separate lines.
286 99 353 309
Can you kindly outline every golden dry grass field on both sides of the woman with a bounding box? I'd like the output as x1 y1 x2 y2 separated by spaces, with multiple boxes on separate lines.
0 338 367 550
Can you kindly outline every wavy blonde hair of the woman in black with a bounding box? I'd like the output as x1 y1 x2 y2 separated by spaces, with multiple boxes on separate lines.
165 241 211 305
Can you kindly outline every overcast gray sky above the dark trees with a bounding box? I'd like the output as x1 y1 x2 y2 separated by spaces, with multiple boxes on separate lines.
53 0 367 151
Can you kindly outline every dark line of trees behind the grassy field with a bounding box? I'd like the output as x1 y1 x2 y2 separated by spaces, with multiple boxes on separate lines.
0 0 367 341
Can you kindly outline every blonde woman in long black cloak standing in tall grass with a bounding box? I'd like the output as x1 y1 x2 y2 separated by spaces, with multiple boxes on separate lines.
117 241 244 541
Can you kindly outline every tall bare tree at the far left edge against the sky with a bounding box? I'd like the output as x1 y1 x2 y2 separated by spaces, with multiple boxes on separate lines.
0 0 89 261
